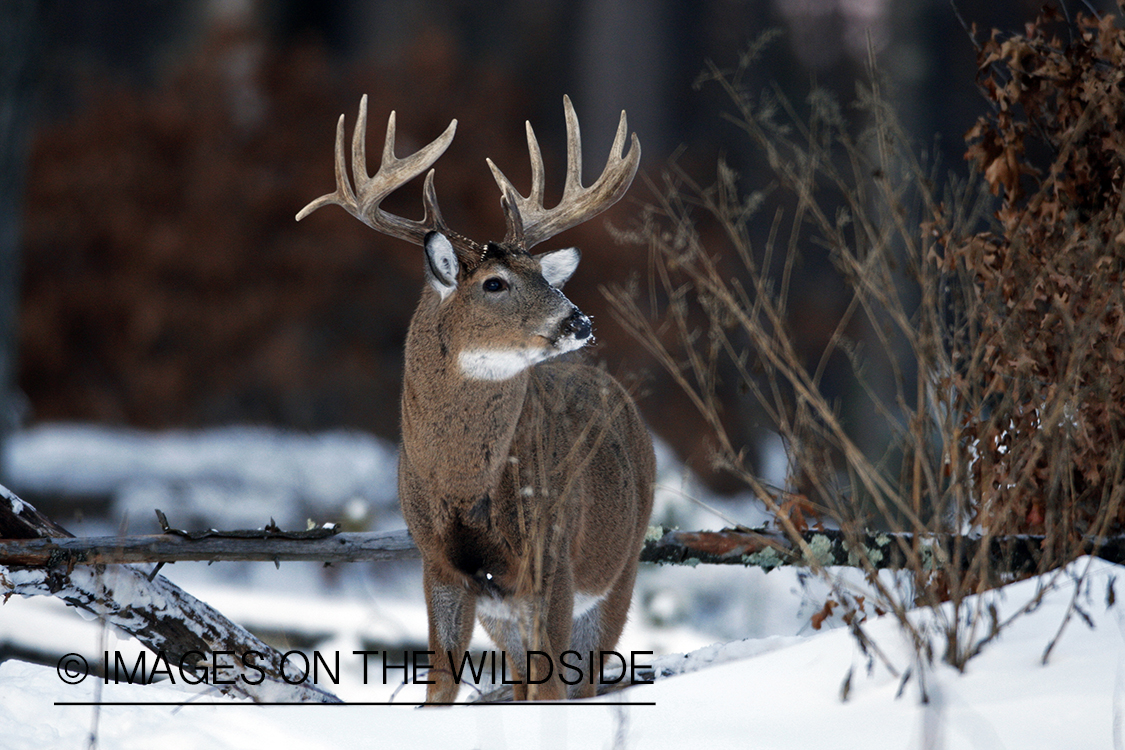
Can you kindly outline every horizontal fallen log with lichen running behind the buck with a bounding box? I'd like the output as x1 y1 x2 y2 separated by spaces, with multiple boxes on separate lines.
0 513 1125 573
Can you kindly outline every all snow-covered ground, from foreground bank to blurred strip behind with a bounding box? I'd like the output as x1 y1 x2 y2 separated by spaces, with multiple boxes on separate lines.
0 426 1125 749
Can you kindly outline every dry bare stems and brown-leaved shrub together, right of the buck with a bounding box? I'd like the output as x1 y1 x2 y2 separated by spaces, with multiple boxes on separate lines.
610 21 1125 679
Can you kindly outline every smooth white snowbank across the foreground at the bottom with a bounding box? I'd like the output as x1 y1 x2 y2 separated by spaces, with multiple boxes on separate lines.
0 560 1125 749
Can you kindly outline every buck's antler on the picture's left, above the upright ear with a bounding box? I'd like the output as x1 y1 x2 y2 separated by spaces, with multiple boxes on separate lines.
297 94 464 249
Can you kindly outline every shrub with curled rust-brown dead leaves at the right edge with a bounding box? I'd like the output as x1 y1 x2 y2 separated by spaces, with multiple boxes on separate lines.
945 9 1125 550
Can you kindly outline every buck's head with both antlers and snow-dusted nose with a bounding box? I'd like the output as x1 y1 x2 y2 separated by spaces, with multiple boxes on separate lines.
297 94 640 380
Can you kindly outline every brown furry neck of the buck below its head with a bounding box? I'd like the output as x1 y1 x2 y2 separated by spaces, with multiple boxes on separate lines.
402 300 529 503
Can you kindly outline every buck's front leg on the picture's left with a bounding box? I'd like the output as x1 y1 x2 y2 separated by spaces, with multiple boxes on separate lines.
422 564 476 703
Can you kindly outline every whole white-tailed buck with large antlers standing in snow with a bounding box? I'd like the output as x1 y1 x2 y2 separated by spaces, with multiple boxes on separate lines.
297 97 655 703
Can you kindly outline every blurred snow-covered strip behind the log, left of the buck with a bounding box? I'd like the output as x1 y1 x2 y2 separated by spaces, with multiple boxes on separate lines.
3 424 396 528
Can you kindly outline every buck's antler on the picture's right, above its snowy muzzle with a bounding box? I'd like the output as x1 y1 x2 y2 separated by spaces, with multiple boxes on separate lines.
487 96 640 250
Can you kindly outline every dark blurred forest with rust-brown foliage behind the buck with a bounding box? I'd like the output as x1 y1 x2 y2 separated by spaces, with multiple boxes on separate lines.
0 0 1089 503
